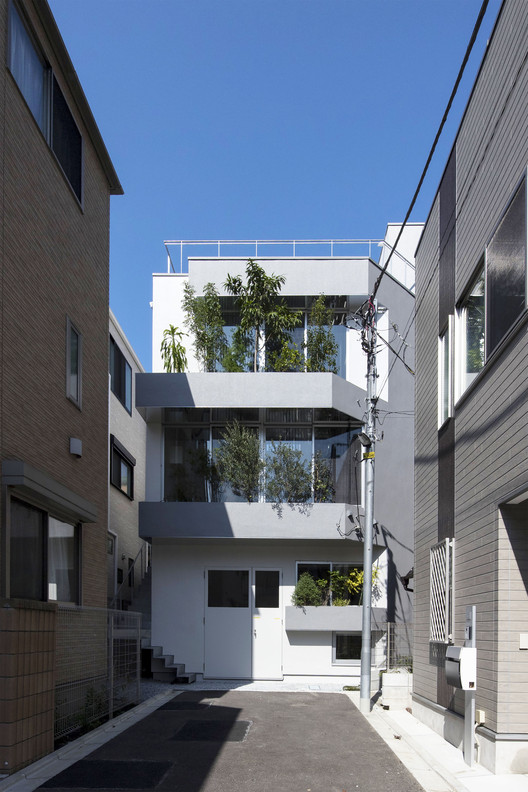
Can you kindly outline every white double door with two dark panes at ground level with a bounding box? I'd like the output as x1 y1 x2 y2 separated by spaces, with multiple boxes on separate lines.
204 568 282 679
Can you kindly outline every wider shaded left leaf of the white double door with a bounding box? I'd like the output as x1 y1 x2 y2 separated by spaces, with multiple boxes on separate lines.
204 569 251 679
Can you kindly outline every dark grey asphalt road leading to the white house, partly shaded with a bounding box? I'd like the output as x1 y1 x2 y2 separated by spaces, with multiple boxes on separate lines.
40 690 423 792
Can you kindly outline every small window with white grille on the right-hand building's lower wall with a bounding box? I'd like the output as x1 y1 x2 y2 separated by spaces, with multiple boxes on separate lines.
429 539 455 644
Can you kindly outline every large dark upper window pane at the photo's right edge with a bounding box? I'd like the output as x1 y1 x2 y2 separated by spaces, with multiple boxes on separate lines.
486 179 526 355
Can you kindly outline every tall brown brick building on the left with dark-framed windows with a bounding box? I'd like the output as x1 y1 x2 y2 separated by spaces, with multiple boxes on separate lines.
0 0 122 773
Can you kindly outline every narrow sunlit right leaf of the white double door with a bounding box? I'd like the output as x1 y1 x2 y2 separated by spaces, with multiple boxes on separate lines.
252 569 282 679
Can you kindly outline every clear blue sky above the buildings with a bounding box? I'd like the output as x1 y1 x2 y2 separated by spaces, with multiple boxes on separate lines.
49 0 500 370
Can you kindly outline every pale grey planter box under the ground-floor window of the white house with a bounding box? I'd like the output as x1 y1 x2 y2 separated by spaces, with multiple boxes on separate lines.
284 605 386 632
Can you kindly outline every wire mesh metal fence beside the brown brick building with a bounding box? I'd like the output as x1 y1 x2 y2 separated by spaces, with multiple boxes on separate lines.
55 605 141 739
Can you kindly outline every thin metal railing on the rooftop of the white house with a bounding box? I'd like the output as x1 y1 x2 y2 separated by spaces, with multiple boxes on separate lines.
164 239 383 275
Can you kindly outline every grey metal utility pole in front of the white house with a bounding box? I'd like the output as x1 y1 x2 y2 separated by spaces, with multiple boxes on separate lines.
359 298 378 713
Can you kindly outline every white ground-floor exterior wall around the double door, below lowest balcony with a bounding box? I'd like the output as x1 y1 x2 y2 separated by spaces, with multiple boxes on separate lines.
152 540 383 677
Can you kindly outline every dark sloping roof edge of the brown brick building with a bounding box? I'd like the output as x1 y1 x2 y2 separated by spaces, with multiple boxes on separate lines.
32 0 124 195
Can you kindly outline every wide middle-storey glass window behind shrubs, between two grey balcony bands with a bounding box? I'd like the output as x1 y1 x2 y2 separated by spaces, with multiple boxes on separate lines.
164 408 361 503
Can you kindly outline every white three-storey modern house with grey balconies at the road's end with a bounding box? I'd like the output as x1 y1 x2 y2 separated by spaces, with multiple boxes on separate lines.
136 225 422 684
